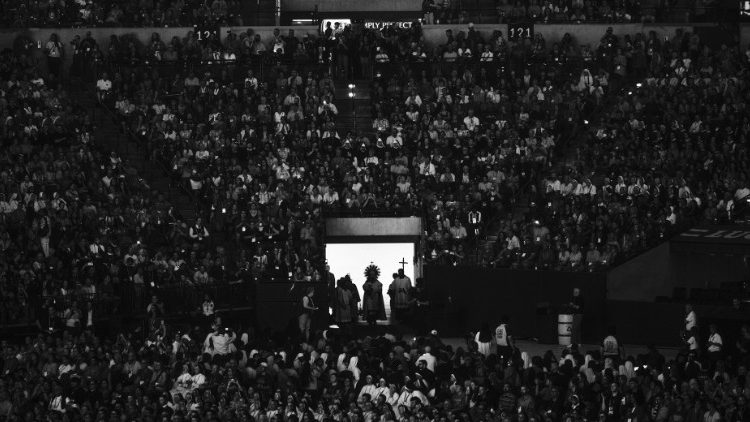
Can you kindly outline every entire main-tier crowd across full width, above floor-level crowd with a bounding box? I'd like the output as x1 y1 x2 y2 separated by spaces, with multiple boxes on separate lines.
0 18 748 328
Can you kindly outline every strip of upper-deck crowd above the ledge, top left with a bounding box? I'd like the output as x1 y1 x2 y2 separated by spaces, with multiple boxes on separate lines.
0 0 243 28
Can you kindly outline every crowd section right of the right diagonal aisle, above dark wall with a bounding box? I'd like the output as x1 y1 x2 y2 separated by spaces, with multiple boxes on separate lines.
508 34 750 269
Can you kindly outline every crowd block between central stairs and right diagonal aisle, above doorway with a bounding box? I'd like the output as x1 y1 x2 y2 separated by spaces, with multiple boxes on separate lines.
368 26 599 264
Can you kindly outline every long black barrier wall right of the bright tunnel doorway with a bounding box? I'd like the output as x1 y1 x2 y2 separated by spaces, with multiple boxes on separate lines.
424 265 607 342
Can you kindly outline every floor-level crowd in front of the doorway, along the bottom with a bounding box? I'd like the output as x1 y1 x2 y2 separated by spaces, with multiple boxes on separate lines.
0 303 750 422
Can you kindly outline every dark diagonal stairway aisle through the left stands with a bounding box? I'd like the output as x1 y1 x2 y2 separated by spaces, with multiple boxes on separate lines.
69 87 197 224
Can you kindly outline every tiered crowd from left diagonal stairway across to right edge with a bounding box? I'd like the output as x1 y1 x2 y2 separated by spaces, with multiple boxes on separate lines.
82 21 747 279
